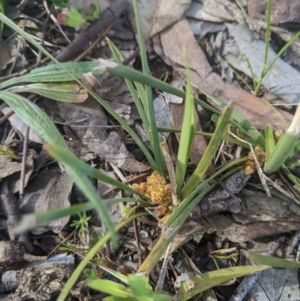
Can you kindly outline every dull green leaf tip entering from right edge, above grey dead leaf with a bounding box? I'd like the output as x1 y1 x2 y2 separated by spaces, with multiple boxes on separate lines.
243 251 300 269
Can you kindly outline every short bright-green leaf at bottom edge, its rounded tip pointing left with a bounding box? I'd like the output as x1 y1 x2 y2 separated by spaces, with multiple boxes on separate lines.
87 279 134 298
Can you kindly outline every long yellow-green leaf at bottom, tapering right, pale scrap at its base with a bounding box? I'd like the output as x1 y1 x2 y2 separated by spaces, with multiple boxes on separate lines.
177 265 269 301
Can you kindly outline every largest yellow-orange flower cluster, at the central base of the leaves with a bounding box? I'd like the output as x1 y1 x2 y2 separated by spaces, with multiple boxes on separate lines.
132 171 172 223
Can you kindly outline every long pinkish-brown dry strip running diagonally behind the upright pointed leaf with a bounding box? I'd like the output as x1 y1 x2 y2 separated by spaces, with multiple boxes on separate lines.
160 19 292 129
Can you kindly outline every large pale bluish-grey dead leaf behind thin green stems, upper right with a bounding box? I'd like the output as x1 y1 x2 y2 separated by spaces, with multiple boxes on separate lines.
222 23 300 103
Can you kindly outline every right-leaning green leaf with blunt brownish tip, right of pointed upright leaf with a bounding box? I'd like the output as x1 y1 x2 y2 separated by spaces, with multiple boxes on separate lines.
179 101 233 200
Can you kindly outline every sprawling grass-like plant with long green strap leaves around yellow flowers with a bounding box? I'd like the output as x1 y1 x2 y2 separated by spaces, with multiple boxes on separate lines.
0 1 300 300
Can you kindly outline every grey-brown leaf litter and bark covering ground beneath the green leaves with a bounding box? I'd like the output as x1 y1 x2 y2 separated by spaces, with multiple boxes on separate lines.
0 0 300 300
